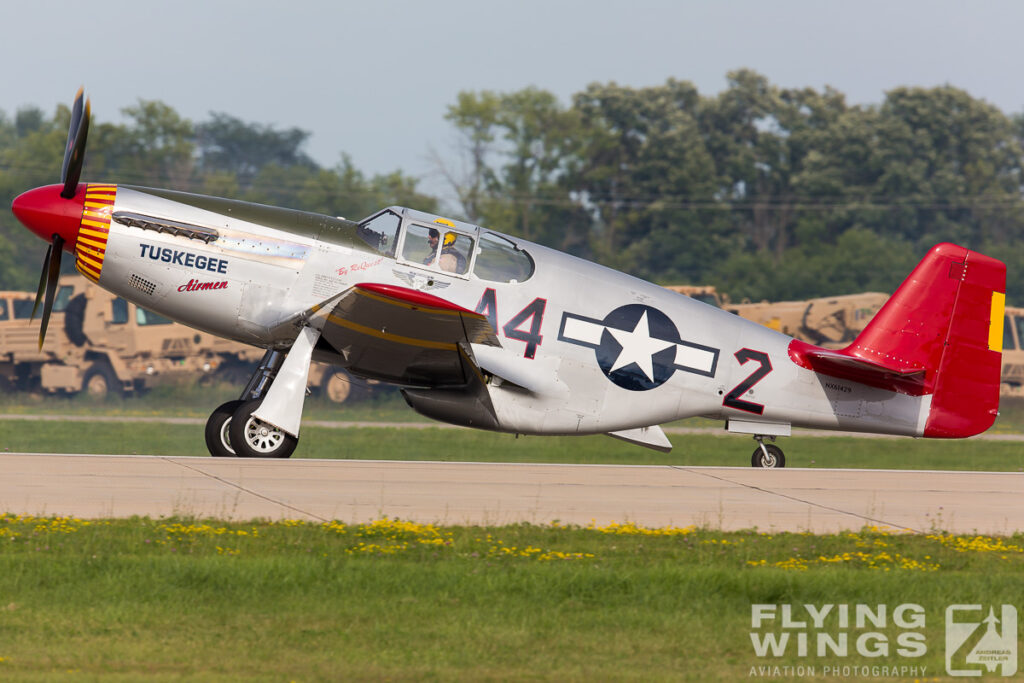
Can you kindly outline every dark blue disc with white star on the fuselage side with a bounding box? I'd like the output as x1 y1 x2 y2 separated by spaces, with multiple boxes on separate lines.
596 303 680 391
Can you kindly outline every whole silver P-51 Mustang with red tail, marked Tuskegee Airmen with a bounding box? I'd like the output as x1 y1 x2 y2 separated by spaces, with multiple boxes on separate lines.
13 91 1006 467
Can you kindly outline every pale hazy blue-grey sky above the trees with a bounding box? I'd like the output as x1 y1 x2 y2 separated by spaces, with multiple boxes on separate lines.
0 0 1024 197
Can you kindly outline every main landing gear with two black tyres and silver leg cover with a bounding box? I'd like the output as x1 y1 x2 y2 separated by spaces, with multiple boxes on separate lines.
206 328 319 458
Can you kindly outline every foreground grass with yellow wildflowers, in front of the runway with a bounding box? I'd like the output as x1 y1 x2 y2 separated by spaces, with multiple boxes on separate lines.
0 515 1024 681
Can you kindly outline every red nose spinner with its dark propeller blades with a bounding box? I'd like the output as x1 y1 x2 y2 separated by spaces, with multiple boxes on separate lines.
11 88 90 348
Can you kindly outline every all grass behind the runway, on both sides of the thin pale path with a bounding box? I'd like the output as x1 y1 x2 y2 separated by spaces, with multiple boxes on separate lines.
0 385 1024 472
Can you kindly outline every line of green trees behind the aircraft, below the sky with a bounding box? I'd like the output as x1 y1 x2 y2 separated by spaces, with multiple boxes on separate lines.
0 70 1024 302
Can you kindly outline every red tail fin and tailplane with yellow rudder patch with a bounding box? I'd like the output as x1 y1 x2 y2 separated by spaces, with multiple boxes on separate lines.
790 244 1007 438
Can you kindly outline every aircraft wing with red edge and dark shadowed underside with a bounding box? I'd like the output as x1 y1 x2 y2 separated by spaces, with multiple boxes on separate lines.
311 283 501 387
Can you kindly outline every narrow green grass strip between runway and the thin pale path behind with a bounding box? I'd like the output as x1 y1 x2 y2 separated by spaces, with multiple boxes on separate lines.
0 420 1024 472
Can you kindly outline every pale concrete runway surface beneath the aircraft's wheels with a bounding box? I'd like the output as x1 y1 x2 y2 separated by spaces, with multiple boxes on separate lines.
0 454 1024 533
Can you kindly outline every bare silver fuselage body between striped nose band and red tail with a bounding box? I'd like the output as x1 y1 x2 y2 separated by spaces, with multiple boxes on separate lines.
99 186 931 435
